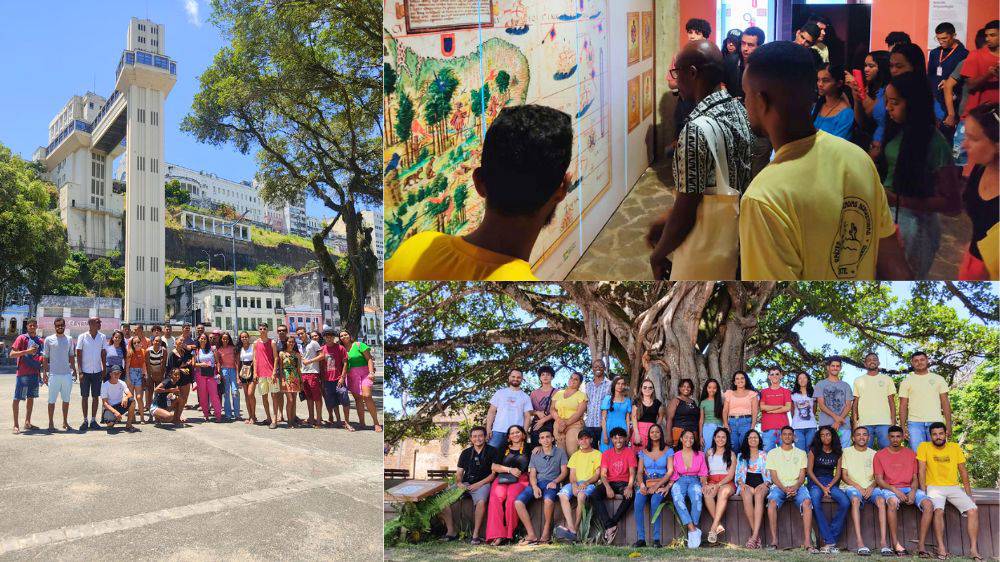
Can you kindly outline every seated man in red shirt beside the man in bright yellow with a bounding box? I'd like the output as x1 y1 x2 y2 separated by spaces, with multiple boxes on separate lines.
872 425 934 556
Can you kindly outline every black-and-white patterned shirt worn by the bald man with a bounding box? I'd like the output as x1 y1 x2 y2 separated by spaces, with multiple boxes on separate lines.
674 90 754 194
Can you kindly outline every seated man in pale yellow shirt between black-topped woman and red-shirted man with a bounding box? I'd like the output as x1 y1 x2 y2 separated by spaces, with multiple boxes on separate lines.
840 425 895 556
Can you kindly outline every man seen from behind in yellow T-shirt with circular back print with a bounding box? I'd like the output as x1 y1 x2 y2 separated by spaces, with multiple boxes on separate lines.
740 41 911 281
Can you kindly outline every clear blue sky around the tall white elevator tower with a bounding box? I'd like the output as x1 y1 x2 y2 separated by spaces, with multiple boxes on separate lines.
0 0 331 217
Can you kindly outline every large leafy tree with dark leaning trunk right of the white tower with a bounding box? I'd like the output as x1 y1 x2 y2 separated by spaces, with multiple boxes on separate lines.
182 0 383 332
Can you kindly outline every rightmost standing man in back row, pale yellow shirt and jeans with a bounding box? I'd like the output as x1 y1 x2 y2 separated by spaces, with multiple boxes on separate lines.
899 351 951 452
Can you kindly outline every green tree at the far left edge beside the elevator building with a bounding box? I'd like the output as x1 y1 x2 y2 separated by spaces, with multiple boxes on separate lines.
0 145 69 301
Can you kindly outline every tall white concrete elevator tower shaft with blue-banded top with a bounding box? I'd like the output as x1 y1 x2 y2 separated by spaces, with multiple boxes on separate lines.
117 18 177 322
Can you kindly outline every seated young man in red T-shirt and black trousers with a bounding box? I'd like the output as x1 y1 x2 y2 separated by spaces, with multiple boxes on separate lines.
590 427 639 544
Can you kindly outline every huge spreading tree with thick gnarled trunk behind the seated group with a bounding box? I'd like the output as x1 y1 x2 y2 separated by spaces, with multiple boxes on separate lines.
385 282 1000 444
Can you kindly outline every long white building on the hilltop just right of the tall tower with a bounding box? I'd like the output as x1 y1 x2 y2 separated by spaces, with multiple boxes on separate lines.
165 163 265 224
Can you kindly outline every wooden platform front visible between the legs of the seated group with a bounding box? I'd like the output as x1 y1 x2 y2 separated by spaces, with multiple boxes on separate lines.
430 489 1000 559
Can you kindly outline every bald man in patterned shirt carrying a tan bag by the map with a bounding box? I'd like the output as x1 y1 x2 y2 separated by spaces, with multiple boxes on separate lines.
649 40 753 280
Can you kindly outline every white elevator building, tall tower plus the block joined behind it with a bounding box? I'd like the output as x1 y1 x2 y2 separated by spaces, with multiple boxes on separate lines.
36 18 177 322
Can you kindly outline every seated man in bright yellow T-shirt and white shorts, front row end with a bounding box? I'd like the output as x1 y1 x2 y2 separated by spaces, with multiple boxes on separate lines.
917 422 982 560
